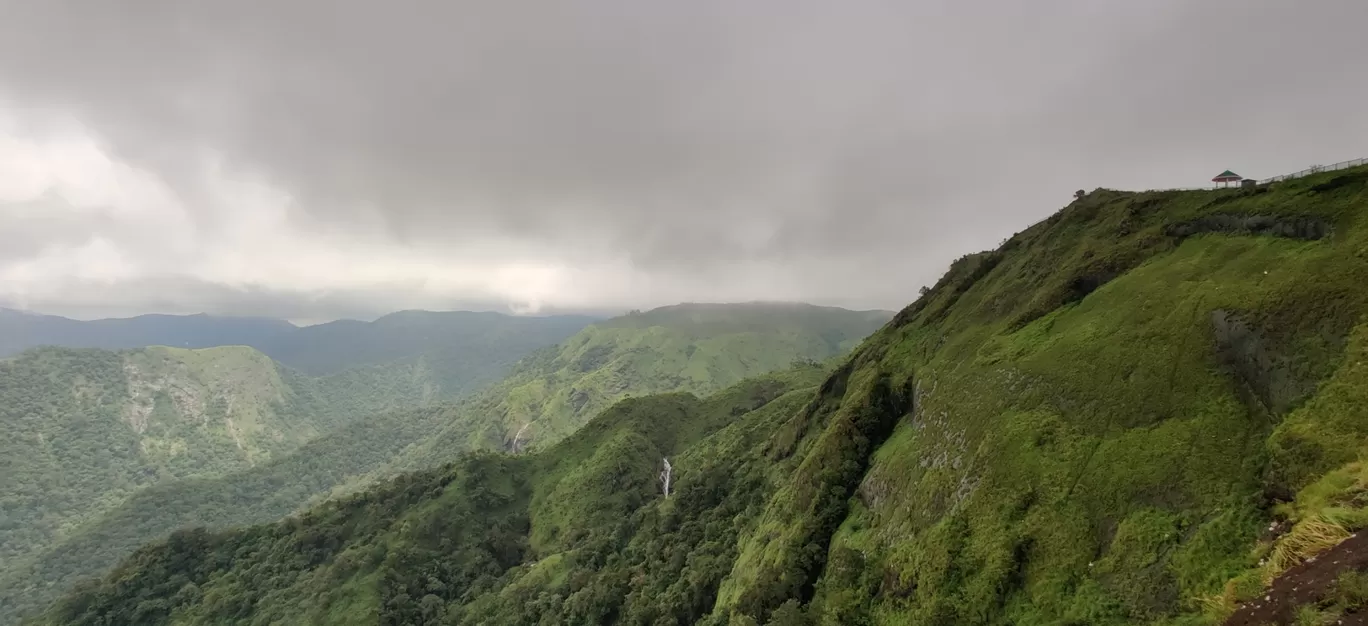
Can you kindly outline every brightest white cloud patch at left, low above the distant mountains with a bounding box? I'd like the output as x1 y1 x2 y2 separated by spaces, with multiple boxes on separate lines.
0 113 590 312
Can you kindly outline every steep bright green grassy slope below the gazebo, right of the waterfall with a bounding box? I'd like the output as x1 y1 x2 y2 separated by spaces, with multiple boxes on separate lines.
718 169 1368 625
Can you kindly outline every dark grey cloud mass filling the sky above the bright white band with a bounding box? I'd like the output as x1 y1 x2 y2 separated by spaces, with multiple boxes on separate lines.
0 0 1368 315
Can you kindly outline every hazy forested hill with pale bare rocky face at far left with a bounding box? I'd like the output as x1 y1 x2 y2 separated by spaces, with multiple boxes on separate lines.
0 347 440 576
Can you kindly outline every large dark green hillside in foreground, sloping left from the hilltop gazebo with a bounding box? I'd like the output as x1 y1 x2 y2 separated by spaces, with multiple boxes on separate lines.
29 168 1368 625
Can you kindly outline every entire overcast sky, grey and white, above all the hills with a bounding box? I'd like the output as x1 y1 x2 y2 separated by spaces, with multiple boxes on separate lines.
0 0 1368 320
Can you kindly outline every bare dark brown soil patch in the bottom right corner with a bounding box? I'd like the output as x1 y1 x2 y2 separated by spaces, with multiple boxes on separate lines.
1224 533 1368 626
